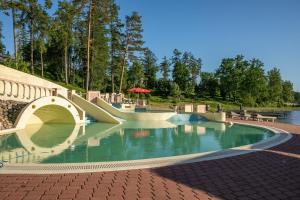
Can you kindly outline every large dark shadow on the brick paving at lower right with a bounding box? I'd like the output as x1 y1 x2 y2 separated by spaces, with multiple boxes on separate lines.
151 134 300 200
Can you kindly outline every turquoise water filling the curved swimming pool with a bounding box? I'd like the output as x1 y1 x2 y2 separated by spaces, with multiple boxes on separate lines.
0 119 274 163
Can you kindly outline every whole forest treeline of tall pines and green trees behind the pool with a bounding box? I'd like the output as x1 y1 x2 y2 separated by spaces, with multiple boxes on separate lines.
0 0 300 106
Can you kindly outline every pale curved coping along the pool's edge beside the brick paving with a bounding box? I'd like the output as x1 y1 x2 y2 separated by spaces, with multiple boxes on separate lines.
0 122 292 174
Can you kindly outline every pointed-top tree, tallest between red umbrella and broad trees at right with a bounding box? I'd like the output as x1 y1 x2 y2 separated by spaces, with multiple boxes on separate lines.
172 49 189 94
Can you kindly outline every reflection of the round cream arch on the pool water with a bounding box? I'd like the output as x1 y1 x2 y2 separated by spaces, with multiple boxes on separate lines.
0 124 84 163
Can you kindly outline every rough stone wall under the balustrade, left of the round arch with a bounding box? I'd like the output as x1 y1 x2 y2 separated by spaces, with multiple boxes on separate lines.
0 100 27 130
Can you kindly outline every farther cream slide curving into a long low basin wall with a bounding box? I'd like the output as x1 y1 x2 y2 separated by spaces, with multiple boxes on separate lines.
97 98 176 121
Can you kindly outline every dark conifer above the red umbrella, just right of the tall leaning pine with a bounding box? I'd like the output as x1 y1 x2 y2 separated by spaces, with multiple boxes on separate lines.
142 48 158 89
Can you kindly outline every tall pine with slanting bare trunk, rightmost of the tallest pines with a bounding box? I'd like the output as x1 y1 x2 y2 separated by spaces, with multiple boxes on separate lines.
119 12 144 93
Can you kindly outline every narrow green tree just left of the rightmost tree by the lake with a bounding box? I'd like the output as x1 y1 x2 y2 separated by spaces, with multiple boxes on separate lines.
268 68 282 102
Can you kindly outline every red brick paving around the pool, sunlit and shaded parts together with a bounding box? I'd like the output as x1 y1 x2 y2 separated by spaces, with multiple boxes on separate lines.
0 122 300 200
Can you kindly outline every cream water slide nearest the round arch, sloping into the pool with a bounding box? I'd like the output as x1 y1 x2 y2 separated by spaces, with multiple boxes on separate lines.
71 94 121 124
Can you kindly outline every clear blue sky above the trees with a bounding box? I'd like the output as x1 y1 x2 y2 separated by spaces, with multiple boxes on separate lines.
0 0 300 91
